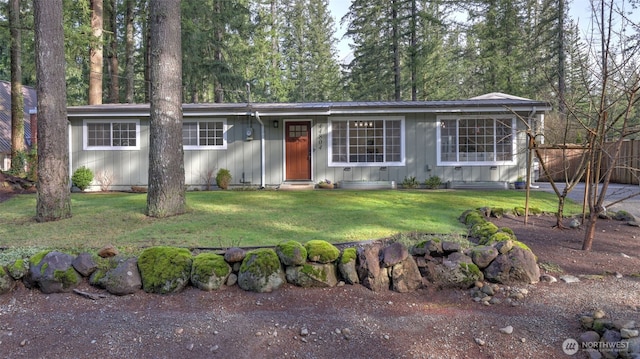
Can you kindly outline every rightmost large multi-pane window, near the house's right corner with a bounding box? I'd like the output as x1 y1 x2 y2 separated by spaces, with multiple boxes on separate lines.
438 116 515 165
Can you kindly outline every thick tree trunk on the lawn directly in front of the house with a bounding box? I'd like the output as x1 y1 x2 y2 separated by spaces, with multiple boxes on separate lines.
147 0 186 217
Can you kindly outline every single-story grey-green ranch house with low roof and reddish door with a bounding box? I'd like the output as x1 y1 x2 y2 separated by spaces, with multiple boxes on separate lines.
68 93 551 190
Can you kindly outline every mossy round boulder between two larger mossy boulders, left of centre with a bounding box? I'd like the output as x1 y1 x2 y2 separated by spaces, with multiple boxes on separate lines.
191 253 231 291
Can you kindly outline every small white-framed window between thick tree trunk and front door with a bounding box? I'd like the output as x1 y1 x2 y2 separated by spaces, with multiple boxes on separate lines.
182 120 227 150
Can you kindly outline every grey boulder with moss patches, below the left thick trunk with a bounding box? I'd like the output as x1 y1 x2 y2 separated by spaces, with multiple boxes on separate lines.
24 251 81 294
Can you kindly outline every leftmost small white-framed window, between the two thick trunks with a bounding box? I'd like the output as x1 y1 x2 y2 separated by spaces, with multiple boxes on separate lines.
83 120 140 150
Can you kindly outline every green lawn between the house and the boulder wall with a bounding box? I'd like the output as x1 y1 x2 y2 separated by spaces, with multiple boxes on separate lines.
0 190 580 253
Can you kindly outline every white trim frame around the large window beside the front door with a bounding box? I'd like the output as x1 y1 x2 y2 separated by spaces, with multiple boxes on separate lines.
327 116 406 167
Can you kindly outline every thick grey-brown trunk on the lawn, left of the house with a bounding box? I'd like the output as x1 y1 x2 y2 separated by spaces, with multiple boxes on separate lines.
33 0 71 222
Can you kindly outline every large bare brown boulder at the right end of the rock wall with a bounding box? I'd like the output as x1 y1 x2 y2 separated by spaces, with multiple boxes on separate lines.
484 246 540 284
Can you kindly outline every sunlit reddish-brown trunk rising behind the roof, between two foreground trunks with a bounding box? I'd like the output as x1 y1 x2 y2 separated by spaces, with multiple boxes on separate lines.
89 0 104 105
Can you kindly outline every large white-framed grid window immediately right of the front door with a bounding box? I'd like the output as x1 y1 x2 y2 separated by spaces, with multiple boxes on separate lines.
329 117 404 166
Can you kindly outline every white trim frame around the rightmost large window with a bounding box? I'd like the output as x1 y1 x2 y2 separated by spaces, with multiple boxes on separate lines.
436 115 517 167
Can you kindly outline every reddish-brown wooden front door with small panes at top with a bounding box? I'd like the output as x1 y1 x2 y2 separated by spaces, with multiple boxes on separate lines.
285 121 311 181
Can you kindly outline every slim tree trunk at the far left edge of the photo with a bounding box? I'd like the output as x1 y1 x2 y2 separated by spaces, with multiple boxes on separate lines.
9 0 26 174
